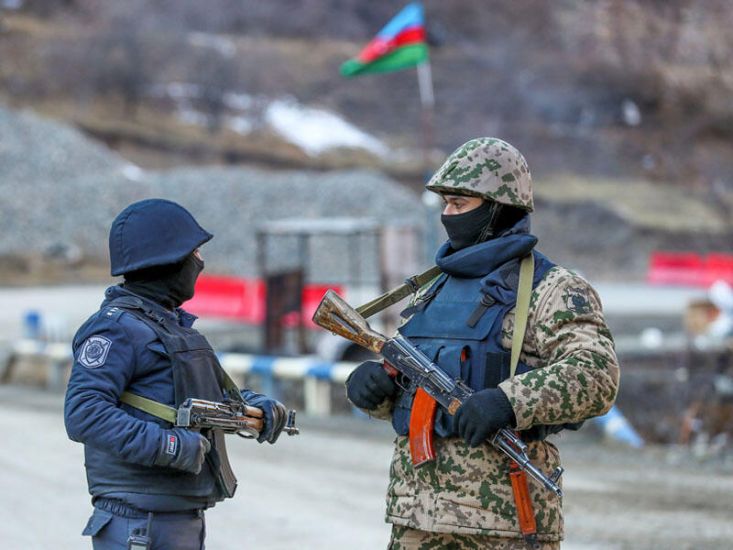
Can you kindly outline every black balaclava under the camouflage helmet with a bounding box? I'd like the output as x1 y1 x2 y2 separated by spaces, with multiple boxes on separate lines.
440 200 526 250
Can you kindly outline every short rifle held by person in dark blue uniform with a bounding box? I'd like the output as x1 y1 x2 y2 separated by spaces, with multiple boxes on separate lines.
175 399 300 438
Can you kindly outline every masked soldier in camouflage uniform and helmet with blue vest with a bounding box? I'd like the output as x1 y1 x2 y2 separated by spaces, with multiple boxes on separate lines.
347 138 619 549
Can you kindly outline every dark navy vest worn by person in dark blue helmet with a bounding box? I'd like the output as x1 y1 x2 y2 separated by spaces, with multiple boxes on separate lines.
85 296 239 501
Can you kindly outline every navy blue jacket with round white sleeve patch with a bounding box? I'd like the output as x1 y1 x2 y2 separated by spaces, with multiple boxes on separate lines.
64 286 213 509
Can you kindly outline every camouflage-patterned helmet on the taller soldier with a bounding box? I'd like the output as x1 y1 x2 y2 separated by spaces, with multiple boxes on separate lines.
425 137 534 212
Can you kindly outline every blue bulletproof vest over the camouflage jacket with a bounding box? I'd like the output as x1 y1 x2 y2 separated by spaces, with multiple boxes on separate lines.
392 252 576 440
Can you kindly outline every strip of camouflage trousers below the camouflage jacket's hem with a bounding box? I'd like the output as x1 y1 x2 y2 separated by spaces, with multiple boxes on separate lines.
387 525 560 550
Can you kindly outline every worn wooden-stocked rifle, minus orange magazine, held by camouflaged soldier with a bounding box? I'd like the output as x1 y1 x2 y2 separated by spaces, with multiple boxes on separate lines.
313 290 563 497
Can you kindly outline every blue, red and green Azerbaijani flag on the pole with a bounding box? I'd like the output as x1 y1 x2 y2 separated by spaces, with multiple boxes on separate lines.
341 2 428 77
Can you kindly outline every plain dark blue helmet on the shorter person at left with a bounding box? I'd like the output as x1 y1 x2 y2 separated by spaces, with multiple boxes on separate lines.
109 199 213 275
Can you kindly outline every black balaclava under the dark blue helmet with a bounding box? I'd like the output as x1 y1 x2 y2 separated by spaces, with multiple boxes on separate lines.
122 253 204 309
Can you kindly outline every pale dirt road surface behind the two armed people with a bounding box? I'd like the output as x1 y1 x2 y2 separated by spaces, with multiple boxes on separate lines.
0 386 733 550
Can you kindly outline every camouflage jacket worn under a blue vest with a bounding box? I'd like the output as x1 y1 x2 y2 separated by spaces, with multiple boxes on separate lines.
371 266 619 541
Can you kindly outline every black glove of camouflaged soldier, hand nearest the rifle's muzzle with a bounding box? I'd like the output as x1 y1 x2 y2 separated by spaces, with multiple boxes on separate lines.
453 388 516 447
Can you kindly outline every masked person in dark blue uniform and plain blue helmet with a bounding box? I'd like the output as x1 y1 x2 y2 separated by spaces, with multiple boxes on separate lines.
64 199 287 550
